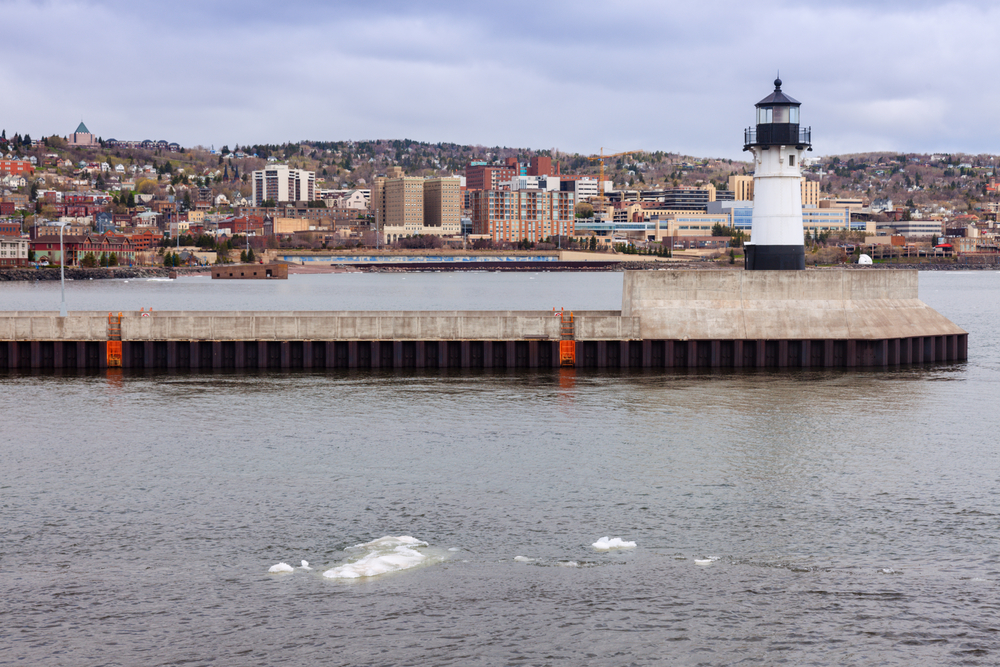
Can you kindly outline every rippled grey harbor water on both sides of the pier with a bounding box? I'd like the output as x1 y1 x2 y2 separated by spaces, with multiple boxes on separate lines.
0 272 1000 665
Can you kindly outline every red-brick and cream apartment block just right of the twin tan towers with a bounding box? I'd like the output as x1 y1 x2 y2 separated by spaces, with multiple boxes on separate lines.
470 190 576 243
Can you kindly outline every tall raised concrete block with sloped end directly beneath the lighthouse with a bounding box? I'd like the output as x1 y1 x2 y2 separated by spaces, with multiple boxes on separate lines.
622 270 966 340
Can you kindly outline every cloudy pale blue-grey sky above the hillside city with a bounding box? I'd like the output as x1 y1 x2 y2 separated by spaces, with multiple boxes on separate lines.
0 0 1000 159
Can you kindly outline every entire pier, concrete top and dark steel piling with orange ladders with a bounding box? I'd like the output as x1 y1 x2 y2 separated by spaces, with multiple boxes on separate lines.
0 270 968 369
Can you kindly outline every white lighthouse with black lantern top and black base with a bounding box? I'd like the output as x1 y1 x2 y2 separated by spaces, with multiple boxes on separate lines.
743 79 812 271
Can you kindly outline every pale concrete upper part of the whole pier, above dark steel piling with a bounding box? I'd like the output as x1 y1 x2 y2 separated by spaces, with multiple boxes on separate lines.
0 270 966 348
